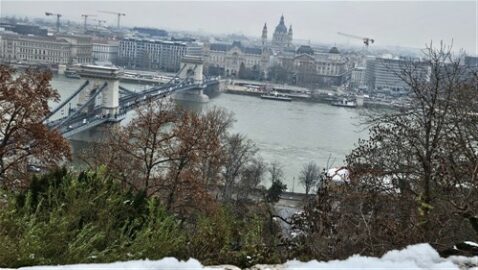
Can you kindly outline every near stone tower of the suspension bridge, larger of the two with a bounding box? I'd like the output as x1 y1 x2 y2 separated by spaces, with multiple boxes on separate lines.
78 65 121 116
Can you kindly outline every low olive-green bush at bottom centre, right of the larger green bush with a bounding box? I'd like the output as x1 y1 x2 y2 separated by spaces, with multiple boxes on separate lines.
188 206 279 267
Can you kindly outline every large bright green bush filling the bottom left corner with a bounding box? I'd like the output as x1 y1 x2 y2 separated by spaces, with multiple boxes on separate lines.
0 169 185 267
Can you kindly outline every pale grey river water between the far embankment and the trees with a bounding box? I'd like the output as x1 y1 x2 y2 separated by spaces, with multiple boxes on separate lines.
52 76 368 192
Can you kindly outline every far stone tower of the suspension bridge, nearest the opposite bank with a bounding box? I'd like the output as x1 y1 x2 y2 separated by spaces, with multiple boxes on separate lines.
175 56 209 103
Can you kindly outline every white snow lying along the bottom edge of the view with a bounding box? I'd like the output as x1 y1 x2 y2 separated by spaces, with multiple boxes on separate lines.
7 244 478 270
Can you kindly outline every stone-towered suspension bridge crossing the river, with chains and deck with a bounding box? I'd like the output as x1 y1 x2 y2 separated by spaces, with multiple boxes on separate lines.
44 57 219 138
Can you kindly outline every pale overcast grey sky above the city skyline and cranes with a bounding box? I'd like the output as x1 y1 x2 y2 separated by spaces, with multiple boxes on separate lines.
0 0 478 55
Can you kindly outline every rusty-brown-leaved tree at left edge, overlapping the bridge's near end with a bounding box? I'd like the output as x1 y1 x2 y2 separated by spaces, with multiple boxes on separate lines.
0 66 70 184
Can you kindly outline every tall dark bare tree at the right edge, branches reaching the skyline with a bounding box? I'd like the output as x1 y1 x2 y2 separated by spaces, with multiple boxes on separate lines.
347 42 478 253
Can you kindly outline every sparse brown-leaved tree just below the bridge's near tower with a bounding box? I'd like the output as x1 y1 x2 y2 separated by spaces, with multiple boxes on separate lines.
82 102 179 194
